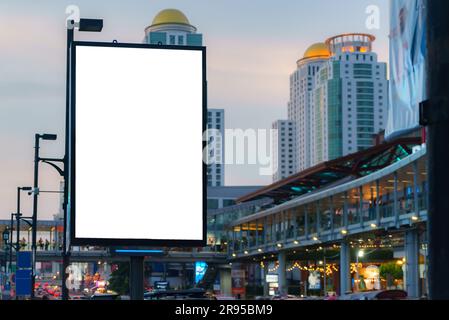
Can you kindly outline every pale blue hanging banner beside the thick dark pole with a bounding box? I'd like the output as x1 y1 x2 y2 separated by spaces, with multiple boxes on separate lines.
385 0 427 139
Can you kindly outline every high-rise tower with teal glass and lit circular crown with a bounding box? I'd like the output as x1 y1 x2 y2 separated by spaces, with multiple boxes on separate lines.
311 34 388 165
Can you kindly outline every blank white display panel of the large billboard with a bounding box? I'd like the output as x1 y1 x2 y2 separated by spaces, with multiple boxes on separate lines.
71 43 205 245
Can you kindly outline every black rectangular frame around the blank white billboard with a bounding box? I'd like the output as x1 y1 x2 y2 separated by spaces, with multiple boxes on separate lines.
68 41 207 248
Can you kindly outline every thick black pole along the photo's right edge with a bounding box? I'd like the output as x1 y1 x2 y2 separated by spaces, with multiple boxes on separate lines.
421 0 449 300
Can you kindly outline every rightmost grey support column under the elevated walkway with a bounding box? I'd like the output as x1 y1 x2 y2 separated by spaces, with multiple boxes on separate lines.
404 229 419 298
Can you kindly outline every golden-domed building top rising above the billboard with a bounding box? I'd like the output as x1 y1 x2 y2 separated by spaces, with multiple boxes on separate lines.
144 9 203 46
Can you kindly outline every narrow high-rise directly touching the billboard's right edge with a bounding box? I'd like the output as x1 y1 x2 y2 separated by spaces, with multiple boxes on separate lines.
207 109 225 187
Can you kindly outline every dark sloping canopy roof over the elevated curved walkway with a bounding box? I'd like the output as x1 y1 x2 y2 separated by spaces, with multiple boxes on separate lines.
237 137 422 204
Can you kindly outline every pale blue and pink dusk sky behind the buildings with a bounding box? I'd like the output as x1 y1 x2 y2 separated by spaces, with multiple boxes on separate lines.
0 0 389 219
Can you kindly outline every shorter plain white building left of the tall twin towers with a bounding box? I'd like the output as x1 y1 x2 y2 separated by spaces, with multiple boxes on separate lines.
272 120 297 181
